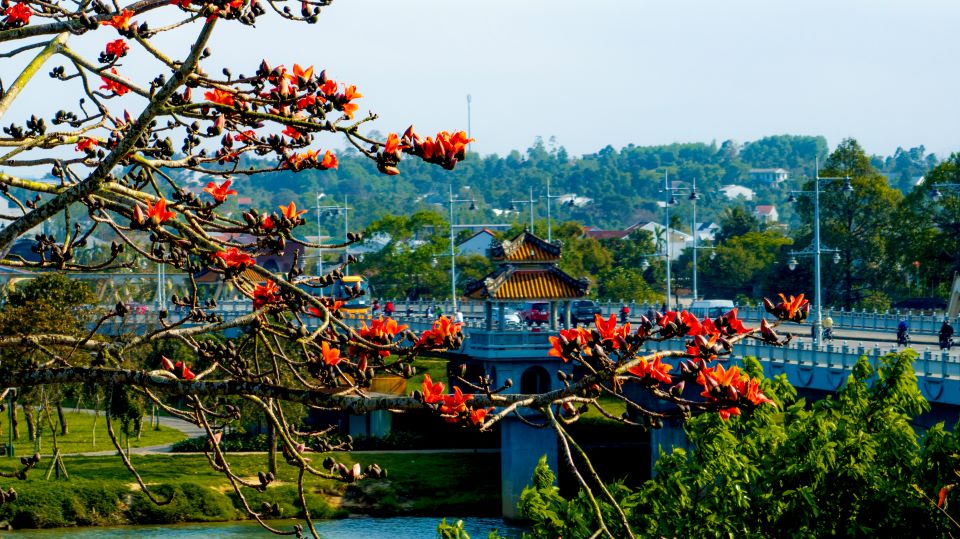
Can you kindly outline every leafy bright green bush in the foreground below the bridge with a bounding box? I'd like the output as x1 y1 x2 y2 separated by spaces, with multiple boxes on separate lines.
502 350 960 539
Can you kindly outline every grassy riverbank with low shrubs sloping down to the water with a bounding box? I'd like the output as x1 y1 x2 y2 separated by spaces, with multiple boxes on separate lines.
0 452 500 529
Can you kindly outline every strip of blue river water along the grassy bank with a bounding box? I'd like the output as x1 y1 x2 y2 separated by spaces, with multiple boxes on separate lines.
3 517 520 539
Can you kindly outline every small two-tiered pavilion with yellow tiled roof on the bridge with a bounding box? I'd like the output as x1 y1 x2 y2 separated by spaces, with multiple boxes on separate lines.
464 230 590 330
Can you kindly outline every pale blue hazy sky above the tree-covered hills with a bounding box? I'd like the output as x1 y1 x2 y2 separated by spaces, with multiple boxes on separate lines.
3 0 960 159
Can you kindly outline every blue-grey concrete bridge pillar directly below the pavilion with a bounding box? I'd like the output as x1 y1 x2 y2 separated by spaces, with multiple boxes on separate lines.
500 416 559 518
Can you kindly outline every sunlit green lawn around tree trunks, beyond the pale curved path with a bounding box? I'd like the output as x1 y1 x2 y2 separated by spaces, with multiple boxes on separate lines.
0 409 186 456
